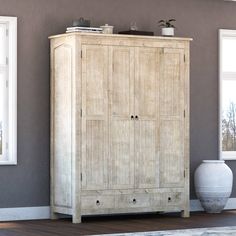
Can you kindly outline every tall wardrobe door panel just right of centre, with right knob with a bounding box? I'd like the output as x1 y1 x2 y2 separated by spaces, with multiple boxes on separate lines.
135 48 160 188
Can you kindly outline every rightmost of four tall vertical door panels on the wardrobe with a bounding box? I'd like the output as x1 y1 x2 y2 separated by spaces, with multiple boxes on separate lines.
159 49 185 187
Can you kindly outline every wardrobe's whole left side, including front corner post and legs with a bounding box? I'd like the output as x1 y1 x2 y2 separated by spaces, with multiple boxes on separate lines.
51 36 81 223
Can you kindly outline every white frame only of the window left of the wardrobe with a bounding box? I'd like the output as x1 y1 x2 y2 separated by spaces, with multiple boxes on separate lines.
0 16 17 165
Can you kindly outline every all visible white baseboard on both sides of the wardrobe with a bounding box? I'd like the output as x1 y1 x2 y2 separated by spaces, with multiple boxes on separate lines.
0 198 236 221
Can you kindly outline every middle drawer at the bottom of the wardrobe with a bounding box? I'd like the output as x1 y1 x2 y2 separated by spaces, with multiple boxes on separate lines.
117 194 160 208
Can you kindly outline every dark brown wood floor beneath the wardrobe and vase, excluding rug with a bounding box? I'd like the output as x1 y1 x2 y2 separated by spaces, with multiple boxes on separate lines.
0 211 236 236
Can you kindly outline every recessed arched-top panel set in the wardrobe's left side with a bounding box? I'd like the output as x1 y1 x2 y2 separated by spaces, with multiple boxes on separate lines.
52 44 72 207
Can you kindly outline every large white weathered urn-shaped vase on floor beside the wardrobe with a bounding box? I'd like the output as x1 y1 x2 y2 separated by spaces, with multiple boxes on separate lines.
194 160 233 213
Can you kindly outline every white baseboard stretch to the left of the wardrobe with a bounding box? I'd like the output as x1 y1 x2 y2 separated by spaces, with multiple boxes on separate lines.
0 206 50 221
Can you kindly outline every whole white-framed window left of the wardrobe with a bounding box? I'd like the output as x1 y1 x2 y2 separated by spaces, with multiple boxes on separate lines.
0 16 17 165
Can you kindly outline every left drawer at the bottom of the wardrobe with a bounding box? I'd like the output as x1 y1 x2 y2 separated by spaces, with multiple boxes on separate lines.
81 196 115 209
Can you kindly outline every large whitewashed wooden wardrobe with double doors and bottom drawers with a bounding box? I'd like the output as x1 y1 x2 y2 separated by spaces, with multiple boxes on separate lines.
50 33 190 223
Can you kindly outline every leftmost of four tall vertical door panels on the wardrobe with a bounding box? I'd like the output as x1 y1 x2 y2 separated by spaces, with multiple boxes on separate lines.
81 45 108 190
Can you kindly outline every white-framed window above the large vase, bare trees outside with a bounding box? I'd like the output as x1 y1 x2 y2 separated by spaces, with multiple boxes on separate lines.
219 30 236 160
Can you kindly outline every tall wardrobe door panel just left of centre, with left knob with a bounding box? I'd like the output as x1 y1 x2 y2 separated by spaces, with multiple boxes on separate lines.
109 46 134 189
